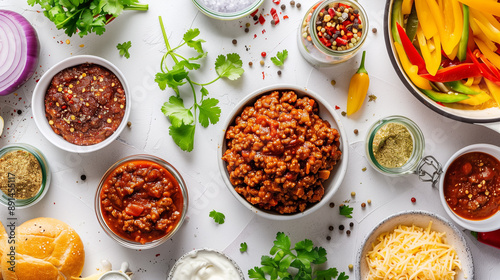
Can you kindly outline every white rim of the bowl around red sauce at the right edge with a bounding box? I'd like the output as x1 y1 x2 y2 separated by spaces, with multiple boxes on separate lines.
439 144 500 232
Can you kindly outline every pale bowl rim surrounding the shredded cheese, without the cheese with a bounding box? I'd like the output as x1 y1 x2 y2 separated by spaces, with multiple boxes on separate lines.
355 210 474 280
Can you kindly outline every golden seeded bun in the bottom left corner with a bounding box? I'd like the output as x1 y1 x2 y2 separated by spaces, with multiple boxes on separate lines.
0 218 85 280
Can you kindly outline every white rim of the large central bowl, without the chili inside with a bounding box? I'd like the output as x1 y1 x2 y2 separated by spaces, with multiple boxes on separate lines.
217 85 349 220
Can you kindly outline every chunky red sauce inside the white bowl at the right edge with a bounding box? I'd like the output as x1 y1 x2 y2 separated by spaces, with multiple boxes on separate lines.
444 152 500 220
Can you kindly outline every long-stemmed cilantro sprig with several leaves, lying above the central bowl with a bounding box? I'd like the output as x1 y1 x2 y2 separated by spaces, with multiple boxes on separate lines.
155 17 244 152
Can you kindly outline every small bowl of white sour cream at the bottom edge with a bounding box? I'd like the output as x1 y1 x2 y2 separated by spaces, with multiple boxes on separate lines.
167 249 245 280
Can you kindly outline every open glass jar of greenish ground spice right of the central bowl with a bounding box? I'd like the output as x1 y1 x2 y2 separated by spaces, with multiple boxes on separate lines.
366 116 425 176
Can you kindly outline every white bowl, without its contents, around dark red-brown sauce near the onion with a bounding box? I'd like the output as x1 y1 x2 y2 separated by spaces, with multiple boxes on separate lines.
31 55 132 153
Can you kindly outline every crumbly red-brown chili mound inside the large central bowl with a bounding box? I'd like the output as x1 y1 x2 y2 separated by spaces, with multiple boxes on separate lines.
222 91 342 214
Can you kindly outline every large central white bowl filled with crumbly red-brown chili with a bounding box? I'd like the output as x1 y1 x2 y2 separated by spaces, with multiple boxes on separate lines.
218 85 348 220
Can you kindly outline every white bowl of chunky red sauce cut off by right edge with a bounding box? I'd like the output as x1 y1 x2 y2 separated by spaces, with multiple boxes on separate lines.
439 144 500 232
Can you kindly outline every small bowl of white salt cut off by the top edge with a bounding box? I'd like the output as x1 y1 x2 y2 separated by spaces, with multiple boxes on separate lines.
193 0 264 20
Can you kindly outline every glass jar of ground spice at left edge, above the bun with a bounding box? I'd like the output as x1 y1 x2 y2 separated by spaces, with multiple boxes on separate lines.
0 143 51 209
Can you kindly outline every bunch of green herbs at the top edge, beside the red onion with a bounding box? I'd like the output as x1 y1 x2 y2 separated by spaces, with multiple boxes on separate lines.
28 0 148 37
